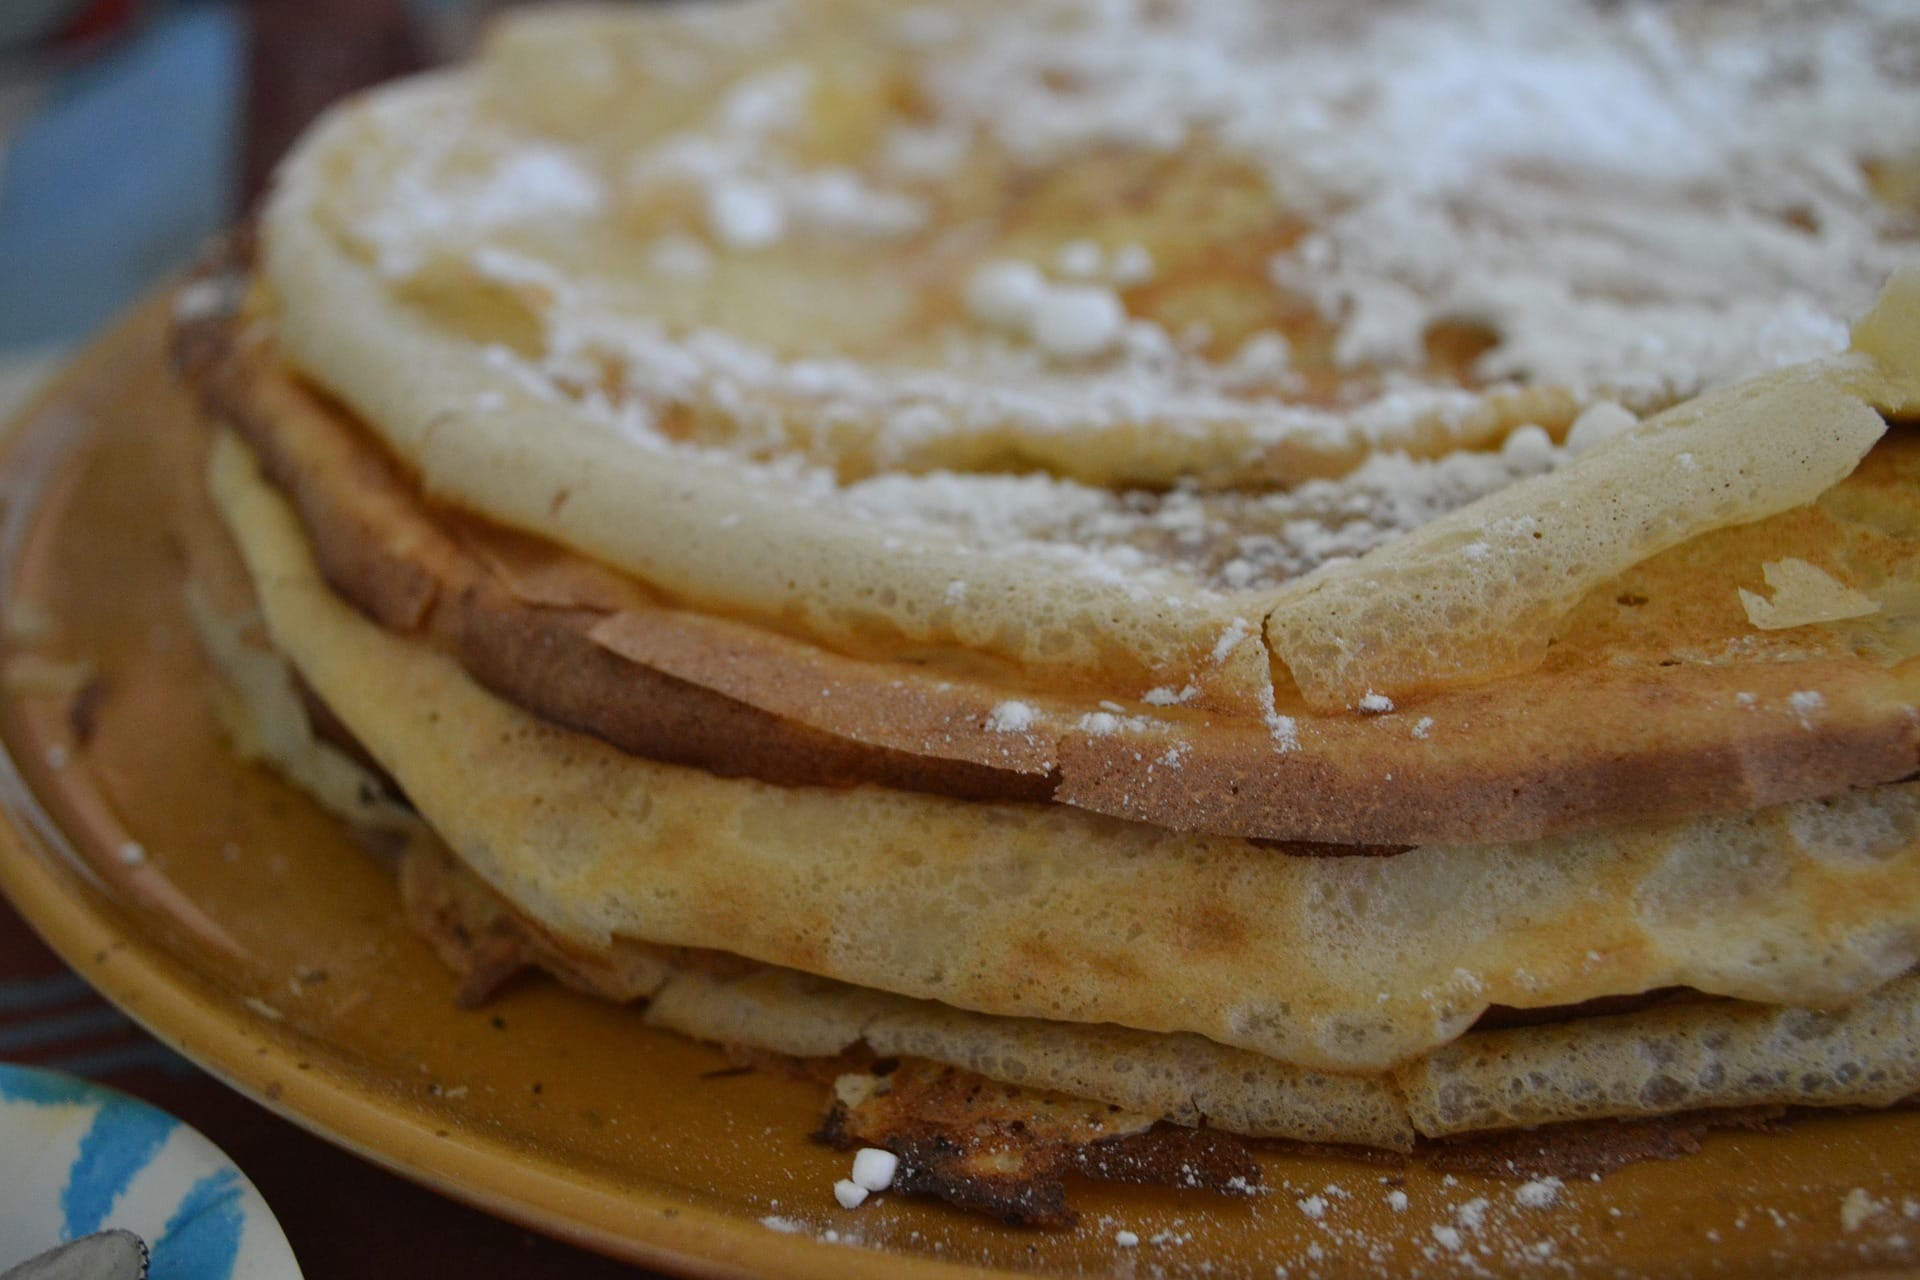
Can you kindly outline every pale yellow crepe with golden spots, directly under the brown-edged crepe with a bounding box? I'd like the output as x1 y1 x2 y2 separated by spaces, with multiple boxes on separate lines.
202 438 1920 1071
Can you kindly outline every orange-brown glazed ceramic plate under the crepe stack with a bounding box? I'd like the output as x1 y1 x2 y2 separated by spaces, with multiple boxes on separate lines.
0 311 1920 1276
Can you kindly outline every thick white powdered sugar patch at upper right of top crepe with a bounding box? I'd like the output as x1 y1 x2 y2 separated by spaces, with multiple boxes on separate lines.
927 0 1920 399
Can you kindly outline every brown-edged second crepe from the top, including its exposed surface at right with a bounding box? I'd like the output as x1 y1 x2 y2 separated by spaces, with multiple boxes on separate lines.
184 289 1920 844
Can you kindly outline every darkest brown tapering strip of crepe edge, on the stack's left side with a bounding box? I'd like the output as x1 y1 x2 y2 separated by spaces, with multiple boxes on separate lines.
175 268 1050 800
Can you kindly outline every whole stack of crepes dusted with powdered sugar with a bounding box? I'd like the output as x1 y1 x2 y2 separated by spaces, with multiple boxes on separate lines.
168 0 1920 1221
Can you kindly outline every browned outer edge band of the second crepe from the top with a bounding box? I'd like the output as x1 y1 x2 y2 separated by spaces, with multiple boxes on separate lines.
177 249 1920 852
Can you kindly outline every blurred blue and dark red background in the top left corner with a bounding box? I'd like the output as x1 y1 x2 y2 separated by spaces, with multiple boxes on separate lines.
0 0 541 415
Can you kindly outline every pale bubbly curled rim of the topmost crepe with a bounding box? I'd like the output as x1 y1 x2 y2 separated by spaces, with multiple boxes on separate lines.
263 42 1920 722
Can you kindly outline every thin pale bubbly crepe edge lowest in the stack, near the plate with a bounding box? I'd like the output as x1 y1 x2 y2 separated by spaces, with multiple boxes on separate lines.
183 460 1920 1150
